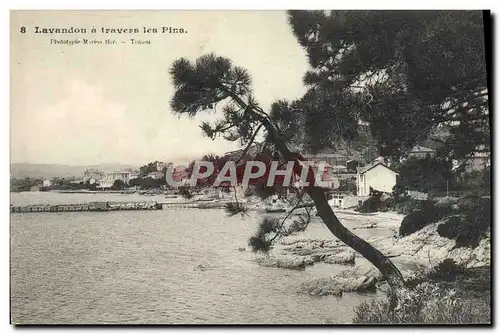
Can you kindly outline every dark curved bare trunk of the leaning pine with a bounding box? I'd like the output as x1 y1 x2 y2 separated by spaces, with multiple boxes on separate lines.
227 91 407 300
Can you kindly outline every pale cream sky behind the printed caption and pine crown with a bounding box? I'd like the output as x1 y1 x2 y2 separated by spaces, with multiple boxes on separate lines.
10 11 308 165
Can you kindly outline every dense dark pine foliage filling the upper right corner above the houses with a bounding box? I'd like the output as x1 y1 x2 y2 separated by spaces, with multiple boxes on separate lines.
283 11 490 159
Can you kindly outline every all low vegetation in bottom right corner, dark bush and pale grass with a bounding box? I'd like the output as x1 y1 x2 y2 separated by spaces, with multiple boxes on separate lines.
354 259 491 324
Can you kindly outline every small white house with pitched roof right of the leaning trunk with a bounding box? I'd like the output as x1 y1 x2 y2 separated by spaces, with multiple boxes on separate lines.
356 161 398 196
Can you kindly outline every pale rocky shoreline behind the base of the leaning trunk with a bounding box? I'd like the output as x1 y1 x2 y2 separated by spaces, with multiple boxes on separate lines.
252 211 491 296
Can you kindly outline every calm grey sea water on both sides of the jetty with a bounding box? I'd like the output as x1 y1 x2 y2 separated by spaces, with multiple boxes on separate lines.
11 193 373 324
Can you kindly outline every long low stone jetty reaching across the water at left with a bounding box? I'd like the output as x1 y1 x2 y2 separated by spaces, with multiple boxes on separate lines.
10 202 162 213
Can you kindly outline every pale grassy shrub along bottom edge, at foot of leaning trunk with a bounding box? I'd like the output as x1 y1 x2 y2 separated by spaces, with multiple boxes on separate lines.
353 283 491 324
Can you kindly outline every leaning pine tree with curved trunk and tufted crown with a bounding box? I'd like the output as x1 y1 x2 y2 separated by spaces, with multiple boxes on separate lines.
170 54 406 295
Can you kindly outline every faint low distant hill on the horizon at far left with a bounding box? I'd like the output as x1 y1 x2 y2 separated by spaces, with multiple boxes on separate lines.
10 163 138 179
